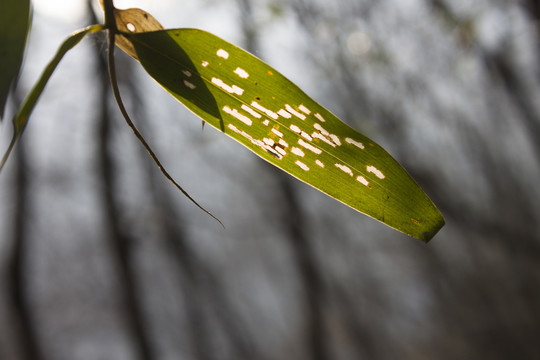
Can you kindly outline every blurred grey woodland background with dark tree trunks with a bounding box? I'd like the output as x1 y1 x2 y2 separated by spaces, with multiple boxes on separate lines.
0 0 540 360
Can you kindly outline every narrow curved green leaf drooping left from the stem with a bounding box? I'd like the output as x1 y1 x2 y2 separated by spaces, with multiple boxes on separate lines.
0 25 103 171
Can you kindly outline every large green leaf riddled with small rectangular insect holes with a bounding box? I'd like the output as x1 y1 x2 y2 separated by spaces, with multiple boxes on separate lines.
124 29 444 242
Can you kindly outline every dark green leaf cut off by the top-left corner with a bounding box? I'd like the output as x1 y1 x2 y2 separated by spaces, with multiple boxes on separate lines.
0 0 31 120
